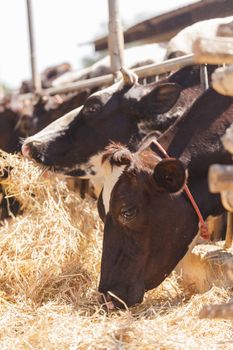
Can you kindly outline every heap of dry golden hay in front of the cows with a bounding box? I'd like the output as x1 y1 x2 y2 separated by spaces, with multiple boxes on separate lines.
0 153 233 350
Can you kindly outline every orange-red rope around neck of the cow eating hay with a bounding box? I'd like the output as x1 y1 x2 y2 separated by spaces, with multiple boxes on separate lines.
153 140 210 240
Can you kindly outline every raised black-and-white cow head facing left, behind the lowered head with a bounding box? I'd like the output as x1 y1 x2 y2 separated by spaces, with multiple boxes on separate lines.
22 72 180 187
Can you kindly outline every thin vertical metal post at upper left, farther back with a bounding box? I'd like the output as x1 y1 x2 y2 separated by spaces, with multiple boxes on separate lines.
27 0 41 93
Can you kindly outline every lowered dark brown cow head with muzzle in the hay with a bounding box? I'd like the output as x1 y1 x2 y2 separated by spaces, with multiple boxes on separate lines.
98 145 198 307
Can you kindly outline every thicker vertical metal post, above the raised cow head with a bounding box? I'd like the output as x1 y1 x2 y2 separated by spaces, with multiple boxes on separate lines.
108 0 124 77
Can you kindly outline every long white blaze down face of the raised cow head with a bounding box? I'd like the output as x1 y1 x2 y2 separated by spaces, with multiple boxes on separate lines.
24 106 83 144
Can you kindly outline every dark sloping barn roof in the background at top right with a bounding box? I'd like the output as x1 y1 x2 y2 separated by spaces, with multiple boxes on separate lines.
94 0 233 51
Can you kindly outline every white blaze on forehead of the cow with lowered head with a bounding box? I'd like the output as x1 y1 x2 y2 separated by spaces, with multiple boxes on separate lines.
102 161 126 214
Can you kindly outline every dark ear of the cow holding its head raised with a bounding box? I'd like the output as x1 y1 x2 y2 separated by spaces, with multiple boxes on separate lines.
140 83 181 116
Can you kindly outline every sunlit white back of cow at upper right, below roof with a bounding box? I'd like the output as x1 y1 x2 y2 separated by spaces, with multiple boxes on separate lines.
165 16 233 59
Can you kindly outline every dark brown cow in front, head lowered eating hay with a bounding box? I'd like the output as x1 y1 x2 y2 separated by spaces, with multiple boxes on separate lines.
98 88 233 308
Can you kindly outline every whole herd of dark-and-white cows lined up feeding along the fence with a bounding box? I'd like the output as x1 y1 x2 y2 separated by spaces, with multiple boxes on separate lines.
0 17 233 308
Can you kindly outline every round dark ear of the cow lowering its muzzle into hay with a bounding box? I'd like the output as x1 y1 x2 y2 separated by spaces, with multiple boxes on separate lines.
153 158 186 193
